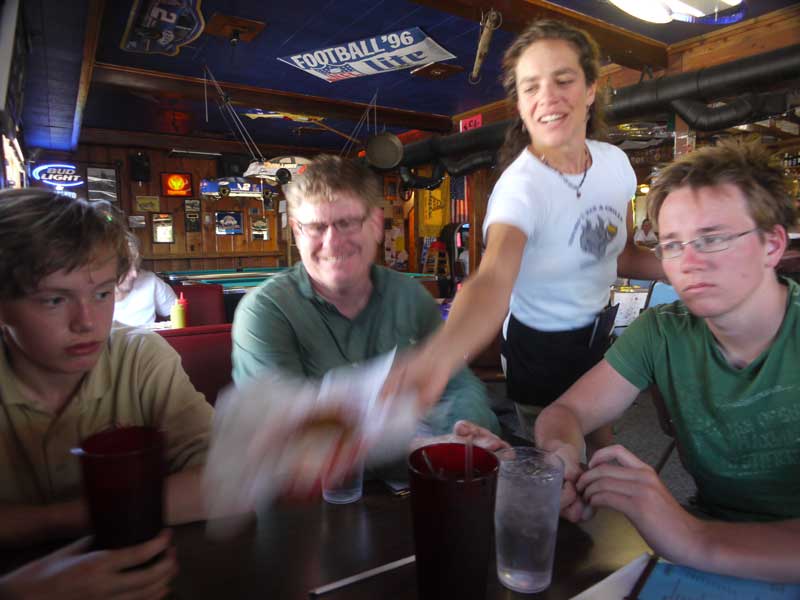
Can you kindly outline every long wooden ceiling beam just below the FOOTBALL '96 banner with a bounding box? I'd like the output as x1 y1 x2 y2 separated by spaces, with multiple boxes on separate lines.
94 62 452 133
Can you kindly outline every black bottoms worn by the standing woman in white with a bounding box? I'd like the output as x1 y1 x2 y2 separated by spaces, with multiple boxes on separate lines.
502 315 609 406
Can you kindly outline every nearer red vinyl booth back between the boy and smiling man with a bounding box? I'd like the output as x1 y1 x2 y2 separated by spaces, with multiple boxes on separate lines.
157 324 232 405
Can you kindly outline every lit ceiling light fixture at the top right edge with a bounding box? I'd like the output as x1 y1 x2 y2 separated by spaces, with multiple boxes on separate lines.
609 0 747 25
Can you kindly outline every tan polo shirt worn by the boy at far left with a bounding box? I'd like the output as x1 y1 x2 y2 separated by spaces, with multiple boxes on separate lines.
0 327 213 504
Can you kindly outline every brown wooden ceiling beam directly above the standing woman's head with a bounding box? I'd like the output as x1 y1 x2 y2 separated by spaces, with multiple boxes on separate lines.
412 0 667 71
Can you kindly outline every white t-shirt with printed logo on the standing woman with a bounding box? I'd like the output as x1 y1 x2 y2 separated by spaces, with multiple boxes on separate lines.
483 140 636 331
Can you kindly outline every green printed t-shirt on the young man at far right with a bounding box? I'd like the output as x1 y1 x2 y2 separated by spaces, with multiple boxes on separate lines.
606 281 800 521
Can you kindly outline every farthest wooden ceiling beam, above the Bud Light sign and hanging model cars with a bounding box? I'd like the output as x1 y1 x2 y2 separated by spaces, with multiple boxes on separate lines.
81 127 330 156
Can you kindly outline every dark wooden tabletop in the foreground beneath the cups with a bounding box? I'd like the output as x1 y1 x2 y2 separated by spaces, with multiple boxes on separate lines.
174 482 648 600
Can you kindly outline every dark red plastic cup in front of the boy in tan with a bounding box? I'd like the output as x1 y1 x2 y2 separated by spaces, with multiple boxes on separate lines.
72 427 165 549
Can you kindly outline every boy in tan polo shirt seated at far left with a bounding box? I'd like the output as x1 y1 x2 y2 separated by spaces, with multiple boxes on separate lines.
0 189 213 596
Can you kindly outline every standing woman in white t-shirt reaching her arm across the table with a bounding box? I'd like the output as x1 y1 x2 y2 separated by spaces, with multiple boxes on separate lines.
385 21 663 447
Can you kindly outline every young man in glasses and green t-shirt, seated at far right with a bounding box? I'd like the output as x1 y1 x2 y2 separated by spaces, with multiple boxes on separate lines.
536 142 800 581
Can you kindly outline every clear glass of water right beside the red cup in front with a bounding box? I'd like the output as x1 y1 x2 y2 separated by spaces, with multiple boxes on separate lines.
494 448 564 594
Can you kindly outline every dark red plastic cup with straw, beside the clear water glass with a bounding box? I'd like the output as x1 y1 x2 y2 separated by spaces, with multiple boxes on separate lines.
408 444 499 600
